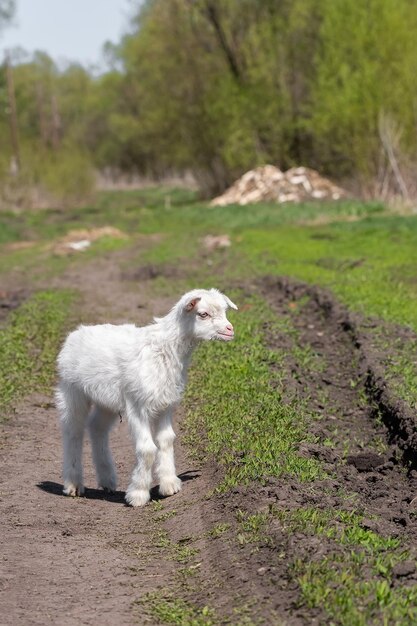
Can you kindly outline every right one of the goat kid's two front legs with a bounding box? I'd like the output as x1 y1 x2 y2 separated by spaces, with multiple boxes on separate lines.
155 411 181 496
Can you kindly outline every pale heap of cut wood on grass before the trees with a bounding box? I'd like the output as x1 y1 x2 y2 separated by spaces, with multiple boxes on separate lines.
211 165 347 206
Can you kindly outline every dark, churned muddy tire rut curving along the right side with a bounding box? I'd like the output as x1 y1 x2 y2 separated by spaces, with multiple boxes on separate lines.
255 278 417 552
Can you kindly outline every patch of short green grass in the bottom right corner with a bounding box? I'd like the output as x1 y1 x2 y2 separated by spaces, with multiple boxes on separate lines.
236 505 417 626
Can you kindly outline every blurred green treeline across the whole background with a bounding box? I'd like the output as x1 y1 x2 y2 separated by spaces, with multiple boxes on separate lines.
0 0 417 203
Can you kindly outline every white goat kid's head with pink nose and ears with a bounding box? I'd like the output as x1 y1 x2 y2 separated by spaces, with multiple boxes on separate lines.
179 289 237 341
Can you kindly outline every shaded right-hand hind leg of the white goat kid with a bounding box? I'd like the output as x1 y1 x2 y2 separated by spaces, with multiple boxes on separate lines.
88 406 117 493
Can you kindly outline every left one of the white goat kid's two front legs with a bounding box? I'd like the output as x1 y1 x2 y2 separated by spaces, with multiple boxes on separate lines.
125 404 156 506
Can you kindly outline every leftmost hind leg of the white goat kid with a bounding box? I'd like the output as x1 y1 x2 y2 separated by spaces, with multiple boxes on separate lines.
56 384 90 496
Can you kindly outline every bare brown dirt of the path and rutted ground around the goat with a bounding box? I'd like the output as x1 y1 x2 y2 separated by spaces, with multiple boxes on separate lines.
0 253 417 626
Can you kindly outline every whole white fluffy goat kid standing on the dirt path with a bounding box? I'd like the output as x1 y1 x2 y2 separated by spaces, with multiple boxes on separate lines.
56 289 237 506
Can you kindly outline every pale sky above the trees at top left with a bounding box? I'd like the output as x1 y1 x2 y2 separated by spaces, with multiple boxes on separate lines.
0 0 139 67
